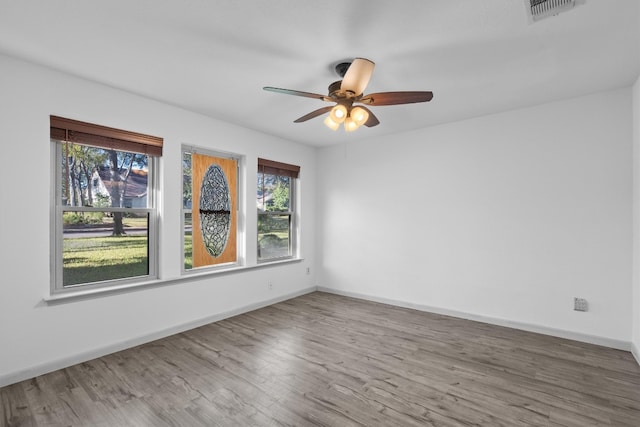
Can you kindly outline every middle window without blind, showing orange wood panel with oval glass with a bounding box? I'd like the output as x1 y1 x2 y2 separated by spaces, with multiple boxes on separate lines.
182 147 240 271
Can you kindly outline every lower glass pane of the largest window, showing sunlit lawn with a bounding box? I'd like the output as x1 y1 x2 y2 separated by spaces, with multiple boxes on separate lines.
62 211 149 286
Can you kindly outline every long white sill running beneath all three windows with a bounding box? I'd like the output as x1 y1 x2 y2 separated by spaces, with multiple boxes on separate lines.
43 258 304 304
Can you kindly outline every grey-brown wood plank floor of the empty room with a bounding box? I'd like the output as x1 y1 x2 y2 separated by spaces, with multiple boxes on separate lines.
0 292 640 427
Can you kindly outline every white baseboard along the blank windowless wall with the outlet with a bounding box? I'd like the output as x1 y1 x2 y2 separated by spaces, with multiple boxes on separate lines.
318 286 640 354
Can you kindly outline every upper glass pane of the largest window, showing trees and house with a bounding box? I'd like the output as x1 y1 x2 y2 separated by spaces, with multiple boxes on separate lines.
60 143 150 208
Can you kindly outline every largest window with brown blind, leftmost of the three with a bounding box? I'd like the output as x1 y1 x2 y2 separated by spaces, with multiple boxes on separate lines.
50 116 163 293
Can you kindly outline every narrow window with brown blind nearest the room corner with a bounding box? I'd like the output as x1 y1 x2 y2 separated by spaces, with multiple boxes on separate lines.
257 159 300 261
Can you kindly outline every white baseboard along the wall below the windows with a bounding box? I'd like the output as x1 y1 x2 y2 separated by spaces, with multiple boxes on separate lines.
0 286 316 387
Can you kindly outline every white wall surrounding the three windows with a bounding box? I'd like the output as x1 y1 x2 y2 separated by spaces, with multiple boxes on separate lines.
0 56 316 386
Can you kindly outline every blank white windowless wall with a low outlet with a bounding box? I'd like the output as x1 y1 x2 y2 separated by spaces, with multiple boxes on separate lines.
318 88 632 349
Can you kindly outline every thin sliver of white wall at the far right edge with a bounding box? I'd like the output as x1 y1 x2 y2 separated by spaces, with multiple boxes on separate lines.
632 77 640 363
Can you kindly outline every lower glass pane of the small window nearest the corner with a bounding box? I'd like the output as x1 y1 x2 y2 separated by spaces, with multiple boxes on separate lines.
258 214 291 260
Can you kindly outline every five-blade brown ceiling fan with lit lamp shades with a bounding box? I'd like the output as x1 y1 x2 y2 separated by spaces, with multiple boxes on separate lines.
263 58 433 132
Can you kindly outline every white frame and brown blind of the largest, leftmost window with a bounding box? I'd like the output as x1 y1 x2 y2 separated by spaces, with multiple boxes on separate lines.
49 116 163 296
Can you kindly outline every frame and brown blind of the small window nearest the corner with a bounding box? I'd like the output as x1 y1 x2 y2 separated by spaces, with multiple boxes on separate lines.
256 158 300 264
